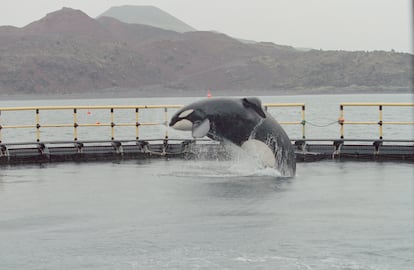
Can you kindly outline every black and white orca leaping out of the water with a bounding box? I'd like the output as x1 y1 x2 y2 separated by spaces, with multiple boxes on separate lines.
169 97 296 177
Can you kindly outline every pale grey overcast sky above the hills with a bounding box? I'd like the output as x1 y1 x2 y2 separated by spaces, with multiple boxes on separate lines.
0 0 413 53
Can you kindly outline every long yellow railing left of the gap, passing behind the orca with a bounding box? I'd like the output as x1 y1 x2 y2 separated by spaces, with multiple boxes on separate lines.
0 103 306 143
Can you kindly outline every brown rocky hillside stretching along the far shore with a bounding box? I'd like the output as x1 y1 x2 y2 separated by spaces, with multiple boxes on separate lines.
0 8 413 95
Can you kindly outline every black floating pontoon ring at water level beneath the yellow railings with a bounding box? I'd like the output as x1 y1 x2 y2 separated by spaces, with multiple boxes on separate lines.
0 140 414 165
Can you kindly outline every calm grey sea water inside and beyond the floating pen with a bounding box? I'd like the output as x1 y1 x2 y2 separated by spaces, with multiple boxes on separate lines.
0 95 414 270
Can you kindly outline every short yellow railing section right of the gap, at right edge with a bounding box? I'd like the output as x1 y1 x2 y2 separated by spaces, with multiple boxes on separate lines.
338 103 414 140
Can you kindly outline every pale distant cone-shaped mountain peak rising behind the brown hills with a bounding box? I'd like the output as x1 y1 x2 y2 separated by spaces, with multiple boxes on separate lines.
98 6 196 33
